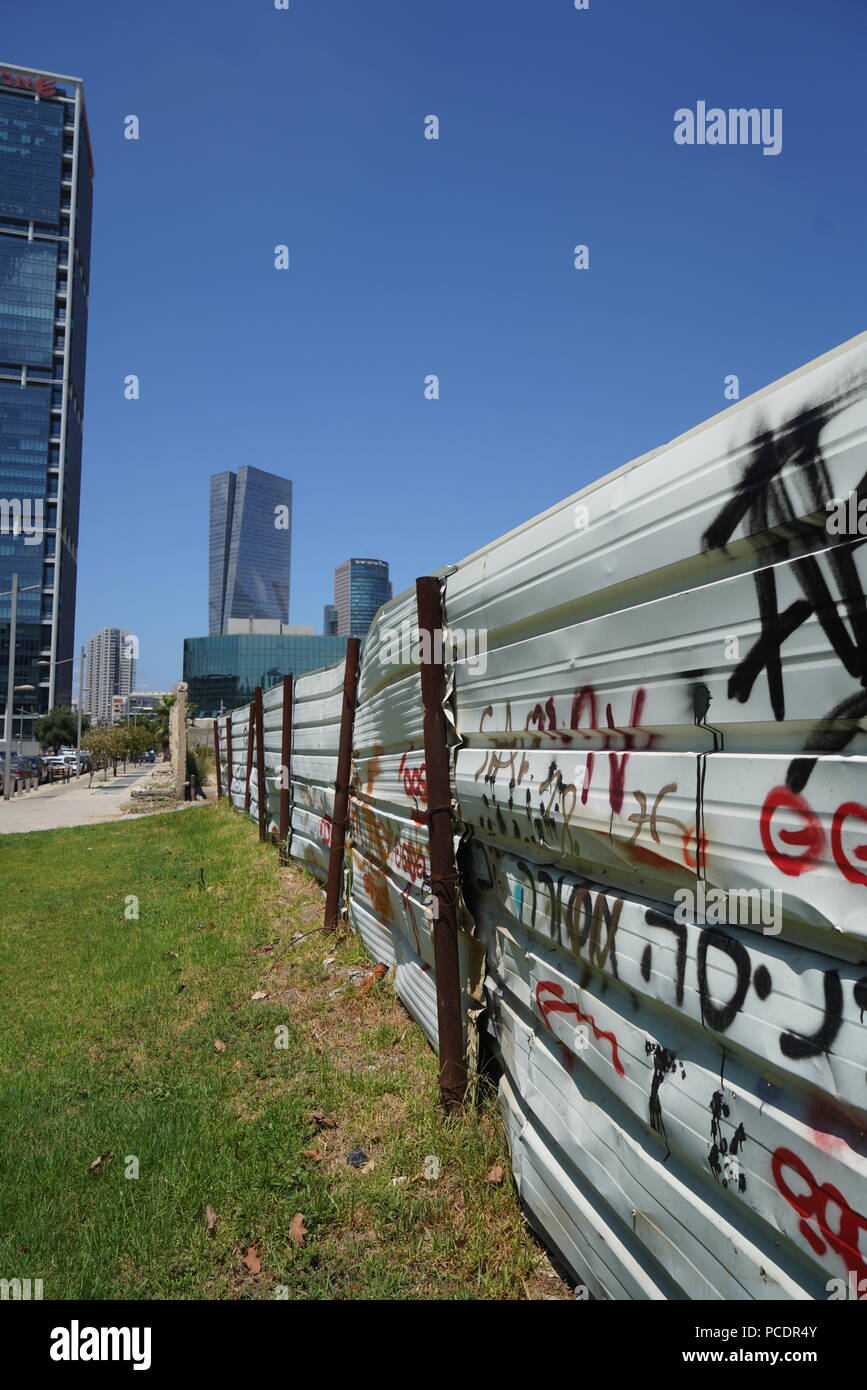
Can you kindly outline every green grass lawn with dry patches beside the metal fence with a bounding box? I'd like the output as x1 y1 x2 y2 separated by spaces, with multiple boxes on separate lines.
0 803 570 1300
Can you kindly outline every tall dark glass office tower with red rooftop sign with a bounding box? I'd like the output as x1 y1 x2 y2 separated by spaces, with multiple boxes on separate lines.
0 67 93 739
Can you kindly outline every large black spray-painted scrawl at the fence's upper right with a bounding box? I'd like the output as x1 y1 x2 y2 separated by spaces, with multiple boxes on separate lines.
702 398 867 792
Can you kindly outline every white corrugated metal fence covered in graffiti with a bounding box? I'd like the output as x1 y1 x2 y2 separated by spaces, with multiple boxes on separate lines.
215 335 867 1298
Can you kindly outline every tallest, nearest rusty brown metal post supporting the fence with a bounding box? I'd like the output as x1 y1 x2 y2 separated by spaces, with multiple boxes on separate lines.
415 575 467 1111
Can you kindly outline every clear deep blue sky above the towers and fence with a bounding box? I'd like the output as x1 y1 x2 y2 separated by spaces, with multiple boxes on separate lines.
0 0 867 688
